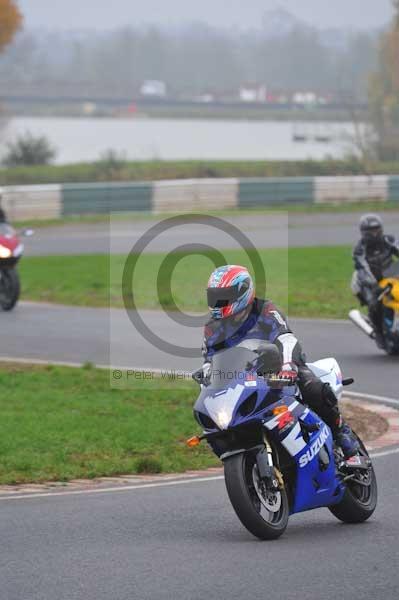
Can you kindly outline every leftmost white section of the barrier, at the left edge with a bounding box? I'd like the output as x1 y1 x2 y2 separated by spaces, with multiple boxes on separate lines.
1 185 62 221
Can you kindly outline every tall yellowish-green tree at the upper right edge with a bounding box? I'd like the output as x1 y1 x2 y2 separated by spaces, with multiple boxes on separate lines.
369 0 399 160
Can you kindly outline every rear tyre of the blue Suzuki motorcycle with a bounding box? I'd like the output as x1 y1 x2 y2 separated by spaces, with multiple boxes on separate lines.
329 438 378 523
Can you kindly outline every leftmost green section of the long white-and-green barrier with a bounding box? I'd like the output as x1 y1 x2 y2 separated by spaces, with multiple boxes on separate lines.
62 182 152 215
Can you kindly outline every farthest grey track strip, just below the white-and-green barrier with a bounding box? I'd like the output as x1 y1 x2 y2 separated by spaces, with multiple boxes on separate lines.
24 211 399 256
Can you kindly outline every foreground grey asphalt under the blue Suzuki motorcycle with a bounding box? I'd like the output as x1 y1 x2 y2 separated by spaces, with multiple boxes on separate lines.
0 438 399 600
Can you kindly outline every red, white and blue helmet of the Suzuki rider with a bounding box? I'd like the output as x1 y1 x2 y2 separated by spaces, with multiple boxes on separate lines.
207 265 255 319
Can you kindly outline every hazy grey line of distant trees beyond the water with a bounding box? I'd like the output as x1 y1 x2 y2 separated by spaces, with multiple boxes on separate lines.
0 23 378 102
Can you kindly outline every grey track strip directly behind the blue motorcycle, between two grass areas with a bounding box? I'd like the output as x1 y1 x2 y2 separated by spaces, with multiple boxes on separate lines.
0 302 399 398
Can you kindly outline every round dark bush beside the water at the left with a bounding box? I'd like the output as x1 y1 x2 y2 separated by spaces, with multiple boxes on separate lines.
3 132 57 167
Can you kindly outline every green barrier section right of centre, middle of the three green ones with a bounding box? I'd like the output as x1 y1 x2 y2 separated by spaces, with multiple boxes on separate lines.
238 177 315 208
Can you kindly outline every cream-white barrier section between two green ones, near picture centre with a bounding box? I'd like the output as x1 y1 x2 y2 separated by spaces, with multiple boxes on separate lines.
152 179 238 213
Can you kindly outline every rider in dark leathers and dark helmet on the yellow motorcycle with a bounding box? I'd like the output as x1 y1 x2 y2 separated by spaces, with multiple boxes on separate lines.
351 214 399 346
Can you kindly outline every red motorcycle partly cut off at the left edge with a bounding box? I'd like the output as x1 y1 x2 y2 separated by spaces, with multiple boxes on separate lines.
0 223 33 310
